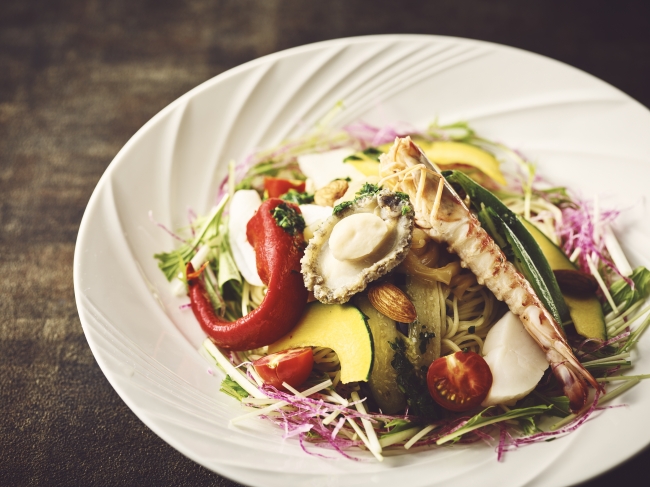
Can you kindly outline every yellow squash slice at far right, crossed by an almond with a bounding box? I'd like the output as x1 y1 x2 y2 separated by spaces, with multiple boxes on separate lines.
521 218 607 340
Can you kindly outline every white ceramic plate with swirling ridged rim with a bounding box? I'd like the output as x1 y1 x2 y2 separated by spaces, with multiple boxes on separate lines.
74 35 650 487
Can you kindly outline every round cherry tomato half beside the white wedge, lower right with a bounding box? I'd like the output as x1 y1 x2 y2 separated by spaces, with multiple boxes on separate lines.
427 351 492 411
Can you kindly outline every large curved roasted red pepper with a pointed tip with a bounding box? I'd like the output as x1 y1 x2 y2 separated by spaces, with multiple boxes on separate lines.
187 198 307 351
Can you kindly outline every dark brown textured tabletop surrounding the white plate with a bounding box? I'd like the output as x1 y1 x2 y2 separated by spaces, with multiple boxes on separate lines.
0 0 650 487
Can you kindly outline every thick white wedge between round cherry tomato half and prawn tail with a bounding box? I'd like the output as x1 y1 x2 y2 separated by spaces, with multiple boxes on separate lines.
482 311 548 406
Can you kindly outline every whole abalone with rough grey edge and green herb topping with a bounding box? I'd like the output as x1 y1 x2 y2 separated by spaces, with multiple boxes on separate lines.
301 184 413 304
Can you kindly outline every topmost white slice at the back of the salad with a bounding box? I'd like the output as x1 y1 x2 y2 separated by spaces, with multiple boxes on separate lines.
298 148 365 189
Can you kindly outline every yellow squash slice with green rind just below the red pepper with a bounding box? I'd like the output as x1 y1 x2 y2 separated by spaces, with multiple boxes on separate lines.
269 302 374 384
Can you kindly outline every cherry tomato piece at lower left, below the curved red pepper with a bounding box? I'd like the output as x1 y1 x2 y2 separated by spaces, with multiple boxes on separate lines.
253 348 314 390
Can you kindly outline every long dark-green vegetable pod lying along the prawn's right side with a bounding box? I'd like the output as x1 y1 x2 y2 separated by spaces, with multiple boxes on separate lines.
442 171 571 324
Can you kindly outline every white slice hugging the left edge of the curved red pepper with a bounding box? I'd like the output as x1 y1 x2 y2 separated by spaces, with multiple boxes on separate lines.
228 189 264 286
